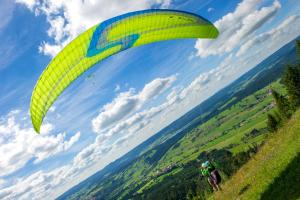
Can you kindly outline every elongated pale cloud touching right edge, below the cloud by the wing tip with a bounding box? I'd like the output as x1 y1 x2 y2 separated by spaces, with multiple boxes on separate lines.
237 15 300 56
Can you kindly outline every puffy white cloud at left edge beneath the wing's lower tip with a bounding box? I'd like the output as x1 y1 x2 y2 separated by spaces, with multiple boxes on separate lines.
0 111 80 176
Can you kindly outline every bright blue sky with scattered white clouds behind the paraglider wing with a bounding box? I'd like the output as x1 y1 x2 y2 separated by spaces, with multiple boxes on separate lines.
0 0 300 199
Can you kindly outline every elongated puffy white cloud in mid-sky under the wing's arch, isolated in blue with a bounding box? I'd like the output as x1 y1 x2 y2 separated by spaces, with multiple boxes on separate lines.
92 76 176 133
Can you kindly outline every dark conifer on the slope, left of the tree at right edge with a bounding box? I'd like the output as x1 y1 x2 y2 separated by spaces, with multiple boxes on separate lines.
272 90 292 120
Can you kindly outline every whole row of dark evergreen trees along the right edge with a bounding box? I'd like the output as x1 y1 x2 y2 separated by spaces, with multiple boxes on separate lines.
267 40 300 132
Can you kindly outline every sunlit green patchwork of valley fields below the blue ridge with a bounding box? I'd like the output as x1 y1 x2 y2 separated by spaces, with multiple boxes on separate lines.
138 81 285 193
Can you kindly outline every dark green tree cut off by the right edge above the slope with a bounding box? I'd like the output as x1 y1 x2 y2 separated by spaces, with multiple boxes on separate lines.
283 65 300 108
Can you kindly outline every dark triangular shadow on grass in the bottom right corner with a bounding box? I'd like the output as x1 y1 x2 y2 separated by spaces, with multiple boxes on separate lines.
261 154 300 200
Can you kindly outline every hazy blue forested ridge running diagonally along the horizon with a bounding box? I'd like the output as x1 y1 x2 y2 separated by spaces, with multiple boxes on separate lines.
57 36 296 199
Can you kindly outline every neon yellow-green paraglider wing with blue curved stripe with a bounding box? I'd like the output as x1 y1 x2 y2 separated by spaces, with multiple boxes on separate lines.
30 9 218 132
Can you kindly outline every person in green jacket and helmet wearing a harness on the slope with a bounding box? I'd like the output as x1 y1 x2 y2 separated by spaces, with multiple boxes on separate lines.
200 161 221 191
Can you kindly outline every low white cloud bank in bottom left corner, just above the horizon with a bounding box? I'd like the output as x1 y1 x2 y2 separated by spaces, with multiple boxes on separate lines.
0 140 109 200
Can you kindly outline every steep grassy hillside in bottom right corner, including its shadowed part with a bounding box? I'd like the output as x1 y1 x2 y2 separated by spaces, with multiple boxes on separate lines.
215 110 300 200
